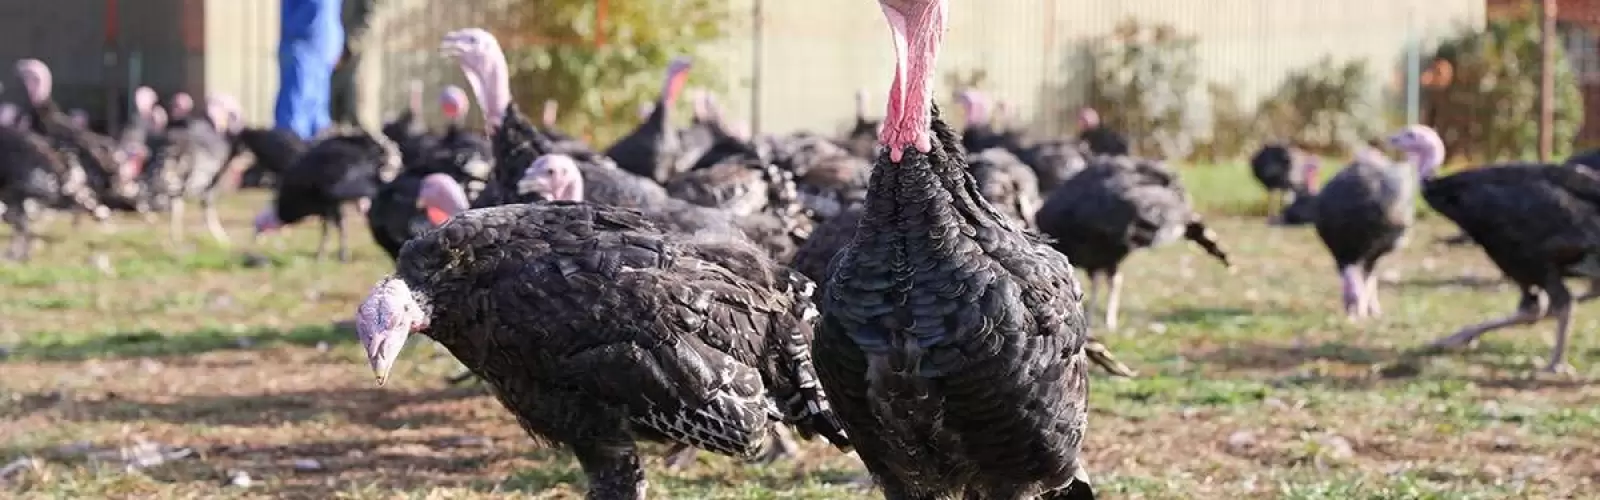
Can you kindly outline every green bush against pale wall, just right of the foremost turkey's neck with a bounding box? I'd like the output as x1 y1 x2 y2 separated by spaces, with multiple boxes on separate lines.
1088 19 1200 159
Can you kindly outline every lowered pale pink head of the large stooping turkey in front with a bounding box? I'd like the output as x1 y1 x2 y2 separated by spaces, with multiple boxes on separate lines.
355 276 429 386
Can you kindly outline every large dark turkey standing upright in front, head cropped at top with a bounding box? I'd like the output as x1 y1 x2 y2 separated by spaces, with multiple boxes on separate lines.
813 0 1094 500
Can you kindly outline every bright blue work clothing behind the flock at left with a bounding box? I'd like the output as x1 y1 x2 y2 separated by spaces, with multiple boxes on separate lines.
272 0 344 139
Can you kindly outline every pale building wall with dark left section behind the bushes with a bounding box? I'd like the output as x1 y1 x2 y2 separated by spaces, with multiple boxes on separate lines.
9 0 1486 142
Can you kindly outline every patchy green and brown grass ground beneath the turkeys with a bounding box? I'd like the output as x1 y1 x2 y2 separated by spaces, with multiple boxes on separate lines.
0 161 1600 500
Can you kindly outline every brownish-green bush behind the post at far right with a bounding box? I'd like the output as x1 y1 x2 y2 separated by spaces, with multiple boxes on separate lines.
1422 16 1584 162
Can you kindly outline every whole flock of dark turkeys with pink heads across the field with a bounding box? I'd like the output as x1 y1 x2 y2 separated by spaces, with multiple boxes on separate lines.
0 0 1600 498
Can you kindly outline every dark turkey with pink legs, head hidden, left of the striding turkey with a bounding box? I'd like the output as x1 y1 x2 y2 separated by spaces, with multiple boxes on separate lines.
1312 147 1416 319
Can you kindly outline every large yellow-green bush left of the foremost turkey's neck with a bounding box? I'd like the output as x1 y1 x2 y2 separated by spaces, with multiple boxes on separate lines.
491 0 730 147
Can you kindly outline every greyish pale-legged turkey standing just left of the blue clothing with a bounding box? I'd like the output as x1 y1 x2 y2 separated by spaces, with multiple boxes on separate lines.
141 95 232 245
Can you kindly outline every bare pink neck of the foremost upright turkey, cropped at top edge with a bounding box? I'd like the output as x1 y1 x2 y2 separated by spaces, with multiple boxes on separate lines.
878 0 950 162
